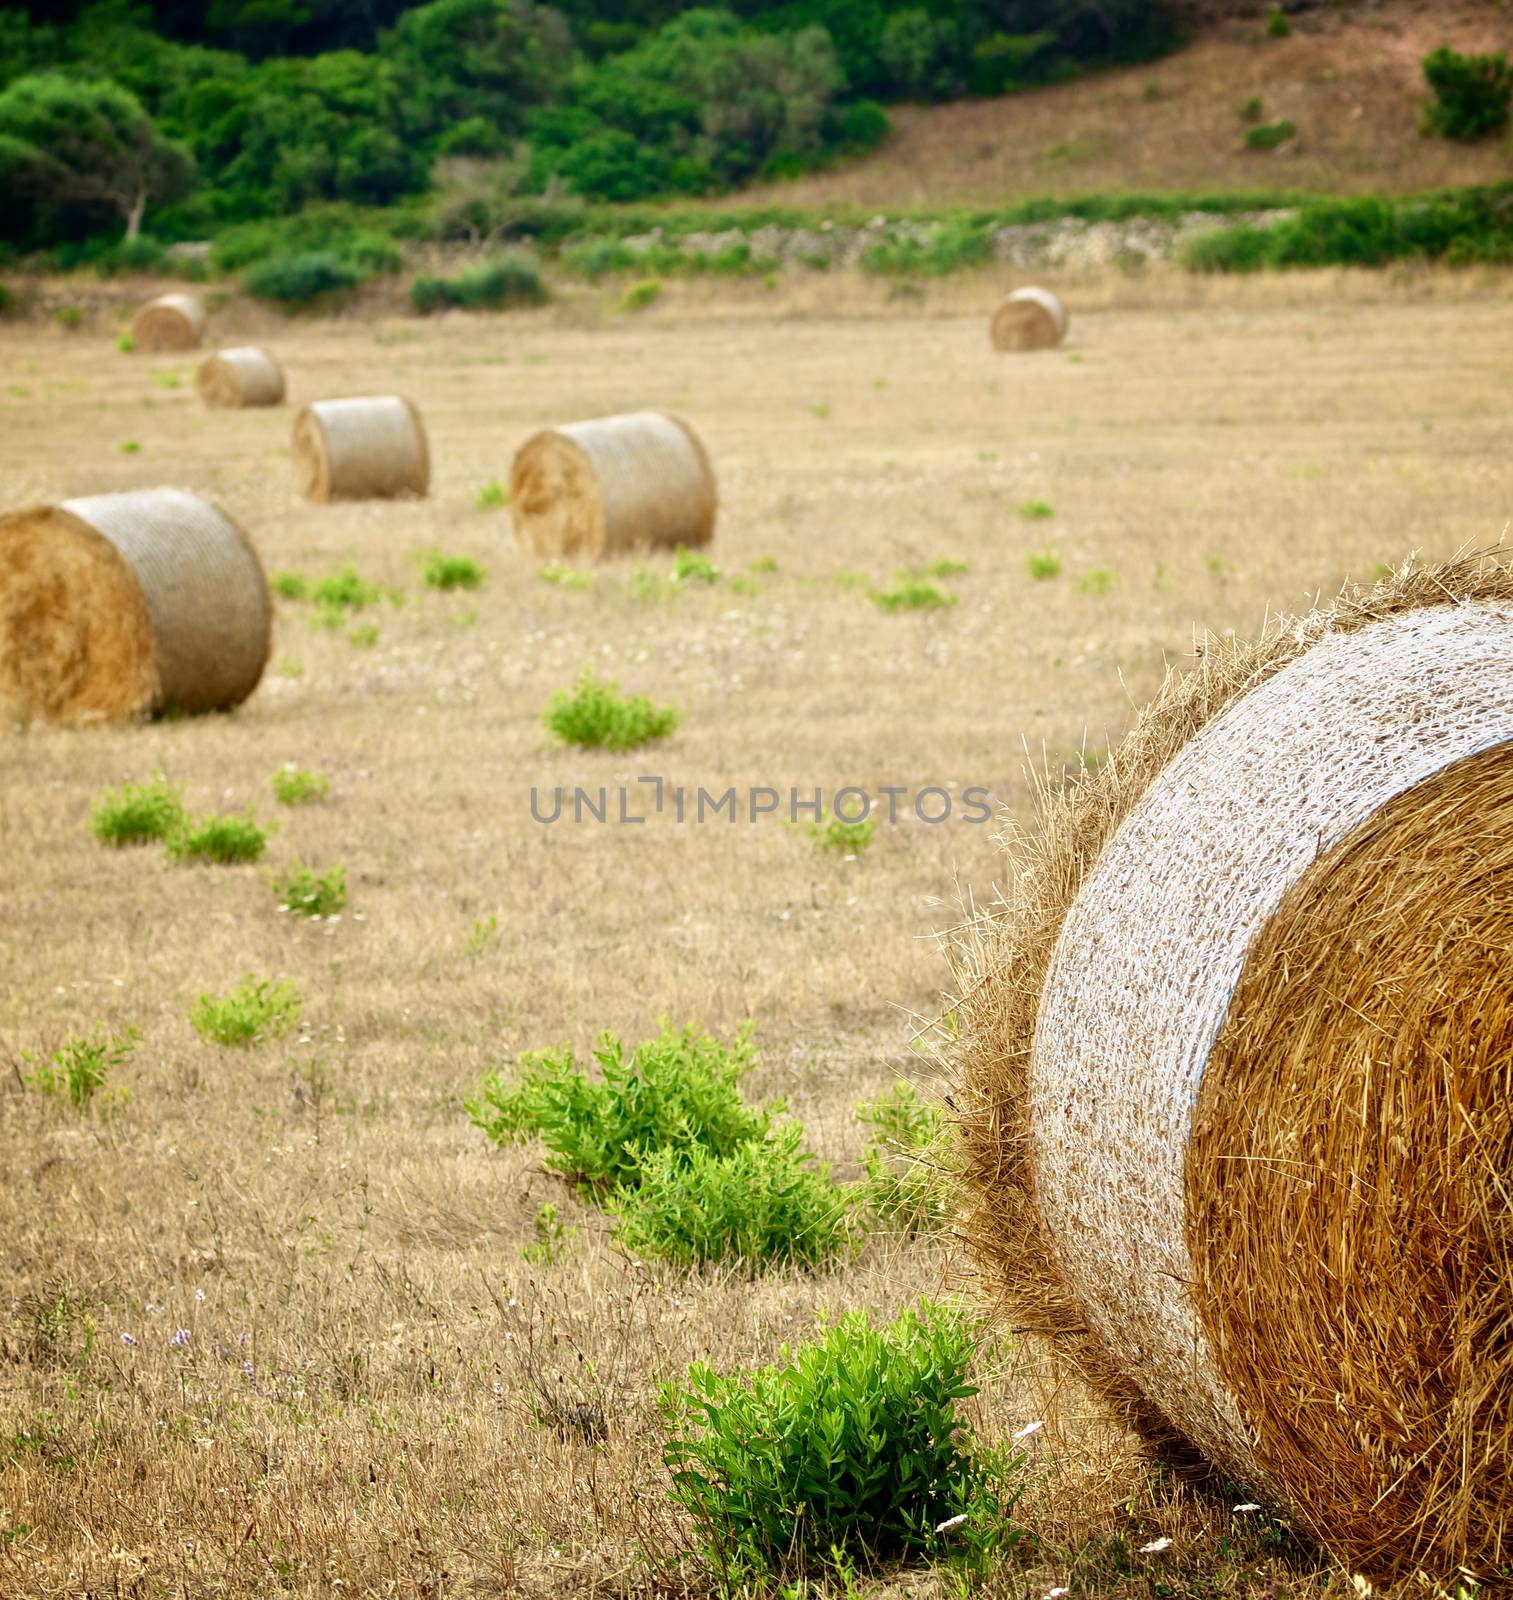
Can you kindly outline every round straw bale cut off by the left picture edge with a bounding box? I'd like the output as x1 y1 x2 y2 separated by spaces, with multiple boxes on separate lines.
0 490 273 722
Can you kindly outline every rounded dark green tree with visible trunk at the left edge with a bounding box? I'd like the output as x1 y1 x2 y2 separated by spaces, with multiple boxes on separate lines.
0 72 194 240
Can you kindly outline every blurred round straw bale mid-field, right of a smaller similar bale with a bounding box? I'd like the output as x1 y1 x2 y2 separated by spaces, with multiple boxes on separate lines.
510 411 718 560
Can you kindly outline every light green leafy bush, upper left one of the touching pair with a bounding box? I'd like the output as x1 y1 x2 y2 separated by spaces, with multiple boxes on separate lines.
464 1024 782 1192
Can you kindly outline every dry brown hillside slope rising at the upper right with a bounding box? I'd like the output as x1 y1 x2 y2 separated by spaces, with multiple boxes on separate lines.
729 0 1513 206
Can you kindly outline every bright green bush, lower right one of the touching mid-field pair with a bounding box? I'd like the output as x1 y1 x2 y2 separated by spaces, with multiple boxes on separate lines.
609 1125 854 1270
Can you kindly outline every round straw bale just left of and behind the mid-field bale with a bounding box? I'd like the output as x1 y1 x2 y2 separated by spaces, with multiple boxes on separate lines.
294 395 430 501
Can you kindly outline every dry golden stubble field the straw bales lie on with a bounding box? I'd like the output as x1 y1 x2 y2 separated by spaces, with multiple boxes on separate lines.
0 268 1513 1600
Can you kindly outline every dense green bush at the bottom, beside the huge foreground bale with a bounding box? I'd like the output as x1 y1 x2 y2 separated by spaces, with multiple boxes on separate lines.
662 1302 1019 1592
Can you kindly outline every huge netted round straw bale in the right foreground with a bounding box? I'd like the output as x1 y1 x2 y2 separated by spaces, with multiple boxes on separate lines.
955 555 1513 1581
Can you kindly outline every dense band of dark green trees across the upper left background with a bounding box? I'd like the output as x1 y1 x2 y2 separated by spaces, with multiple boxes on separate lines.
0 0 1177 248
